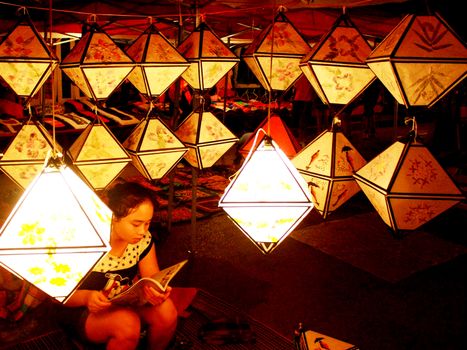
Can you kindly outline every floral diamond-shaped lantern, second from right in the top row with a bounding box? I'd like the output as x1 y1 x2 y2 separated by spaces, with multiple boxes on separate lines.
300 13 376 105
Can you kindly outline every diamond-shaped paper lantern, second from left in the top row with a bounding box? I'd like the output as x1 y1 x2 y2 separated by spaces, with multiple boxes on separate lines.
60 22 135 101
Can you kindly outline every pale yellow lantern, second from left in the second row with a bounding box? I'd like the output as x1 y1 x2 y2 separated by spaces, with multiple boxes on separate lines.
67 119 131 190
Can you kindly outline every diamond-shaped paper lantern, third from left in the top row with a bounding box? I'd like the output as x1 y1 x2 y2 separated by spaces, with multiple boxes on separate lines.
126 23 190 100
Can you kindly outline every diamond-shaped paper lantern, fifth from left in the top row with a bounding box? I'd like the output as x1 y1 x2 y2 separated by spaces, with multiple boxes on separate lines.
242 8 310 91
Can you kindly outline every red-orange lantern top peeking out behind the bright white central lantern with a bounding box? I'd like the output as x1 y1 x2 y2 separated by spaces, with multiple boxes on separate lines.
239 114 301 158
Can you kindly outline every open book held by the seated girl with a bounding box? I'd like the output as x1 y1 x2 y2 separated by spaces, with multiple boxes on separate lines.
110 260 188 306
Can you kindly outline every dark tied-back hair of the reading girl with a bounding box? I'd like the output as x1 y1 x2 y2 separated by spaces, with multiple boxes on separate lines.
106 182 157 218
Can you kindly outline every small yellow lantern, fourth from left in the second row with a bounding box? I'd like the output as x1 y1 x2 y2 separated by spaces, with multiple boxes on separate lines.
175 108 238 169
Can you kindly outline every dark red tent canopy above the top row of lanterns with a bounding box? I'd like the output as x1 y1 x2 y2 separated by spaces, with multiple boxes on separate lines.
0 0 465 43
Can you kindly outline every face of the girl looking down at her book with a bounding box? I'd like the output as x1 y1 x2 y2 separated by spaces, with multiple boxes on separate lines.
112 200 154 244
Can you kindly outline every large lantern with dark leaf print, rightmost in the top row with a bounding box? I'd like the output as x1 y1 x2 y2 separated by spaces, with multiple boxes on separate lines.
366 15 467 108
